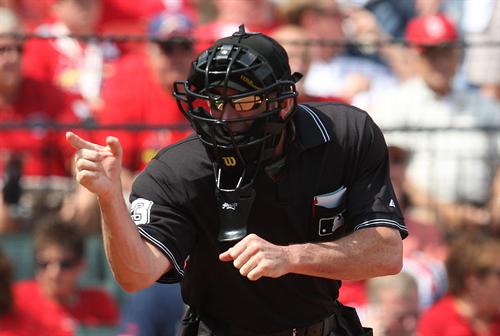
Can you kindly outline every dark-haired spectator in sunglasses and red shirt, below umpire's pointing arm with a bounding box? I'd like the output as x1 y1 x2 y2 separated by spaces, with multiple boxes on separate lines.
14 216 119 335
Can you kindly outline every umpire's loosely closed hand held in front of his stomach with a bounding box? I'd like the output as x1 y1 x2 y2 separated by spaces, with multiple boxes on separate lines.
219 234 290 280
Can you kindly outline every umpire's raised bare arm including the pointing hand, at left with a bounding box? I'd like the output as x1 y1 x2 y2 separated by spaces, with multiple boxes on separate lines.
66 132 172 291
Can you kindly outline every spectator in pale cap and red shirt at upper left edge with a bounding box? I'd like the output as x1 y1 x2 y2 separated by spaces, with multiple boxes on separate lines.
0 8 69 176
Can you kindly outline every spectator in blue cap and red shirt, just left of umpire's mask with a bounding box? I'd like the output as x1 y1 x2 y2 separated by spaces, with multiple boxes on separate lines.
61 12 194 232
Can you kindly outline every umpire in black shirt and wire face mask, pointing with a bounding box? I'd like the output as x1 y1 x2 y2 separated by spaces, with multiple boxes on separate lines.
67 26 407 336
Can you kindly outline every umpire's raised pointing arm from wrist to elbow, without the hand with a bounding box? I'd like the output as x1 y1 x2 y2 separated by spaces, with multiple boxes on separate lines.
99 194 170 291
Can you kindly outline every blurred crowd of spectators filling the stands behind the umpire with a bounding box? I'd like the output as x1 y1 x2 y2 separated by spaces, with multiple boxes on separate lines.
0 0 500 336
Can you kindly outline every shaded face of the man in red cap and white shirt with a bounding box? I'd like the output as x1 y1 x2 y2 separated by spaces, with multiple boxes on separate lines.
417 47 460 95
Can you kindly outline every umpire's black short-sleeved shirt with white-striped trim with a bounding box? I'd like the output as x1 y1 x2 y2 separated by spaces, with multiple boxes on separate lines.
130 102 408 333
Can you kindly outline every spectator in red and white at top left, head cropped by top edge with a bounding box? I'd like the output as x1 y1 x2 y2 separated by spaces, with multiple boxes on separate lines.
24 0 119 110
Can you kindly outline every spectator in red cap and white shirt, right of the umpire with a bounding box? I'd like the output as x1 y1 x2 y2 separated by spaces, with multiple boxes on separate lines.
369 13 500 231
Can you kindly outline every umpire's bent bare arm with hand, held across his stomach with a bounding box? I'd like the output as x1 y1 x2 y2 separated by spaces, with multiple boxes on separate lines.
219 227 403 280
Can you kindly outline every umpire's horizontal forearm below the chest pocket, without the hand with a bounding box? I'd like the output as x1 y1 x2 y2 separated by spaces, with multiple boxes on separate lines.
286 227 402 280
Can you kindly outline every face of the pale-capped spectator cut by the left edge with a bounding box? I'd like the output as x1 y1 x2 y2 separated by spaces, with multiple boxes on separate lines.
0 37 23 88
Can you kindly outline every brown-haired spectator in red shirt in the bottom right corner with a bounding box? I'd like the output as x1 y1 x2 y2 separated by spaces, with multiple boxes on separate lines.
417 233 500 336
